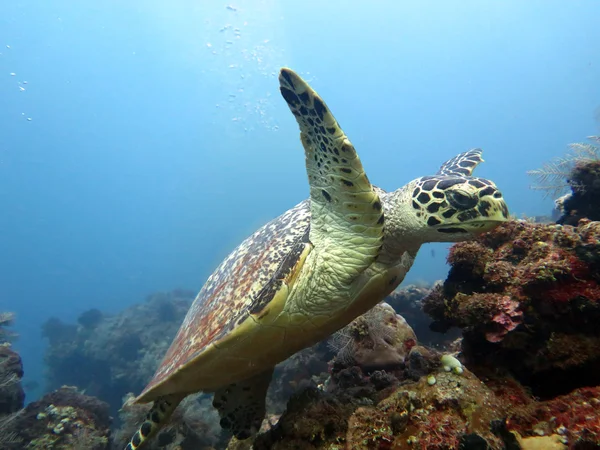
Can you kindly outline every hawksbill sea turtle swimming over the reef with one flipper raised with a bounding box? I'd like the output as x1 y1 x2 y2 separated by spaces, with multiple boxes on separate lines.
126 68 508 450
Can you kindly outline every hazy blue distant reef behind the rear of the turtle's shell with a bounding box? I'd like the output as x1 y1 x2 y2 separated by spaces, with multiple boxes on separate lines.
42 290 194 417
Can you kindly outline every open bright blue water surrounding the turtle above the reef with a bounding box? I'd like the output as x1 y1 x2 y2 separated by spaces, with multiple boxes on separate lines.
0 0 600 400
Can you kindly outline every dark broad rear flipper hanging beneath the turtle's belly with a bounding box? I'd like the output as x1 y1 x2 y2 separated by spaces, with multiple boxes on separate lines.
213 368 273 440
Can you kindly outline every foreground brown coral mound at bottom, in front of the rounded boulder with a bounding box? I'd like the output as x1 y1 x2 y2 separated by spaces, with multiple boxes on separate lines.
253 347 505 450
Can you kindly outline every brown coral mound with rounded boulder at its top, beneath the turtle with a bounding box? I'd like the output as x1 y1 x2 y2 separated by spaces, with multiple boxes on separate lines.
246 303 514 450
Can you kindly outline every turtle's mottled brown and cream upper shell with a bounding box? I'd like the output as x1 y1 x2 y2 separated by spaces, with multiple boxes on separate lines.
136 200 310 402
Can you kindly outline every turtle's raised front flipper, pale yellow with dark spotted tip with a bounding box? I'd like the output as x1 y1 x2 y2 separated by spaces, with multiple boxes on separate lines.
279 68 384 278
